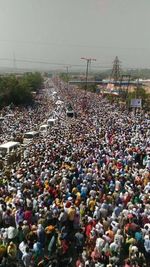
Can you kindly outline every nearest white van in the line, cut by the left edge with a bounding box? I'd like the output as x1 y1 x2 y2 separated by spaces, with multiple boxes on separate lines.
0 141 20 157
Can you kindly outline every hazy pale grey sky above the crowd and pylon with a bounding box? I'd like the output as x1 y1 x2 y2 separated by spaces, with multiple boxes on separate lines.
0 0 150 69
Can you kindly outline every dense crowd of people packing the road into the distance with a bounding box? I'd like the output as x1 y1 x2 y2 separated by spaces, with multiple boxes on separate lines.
0 76 150 267
